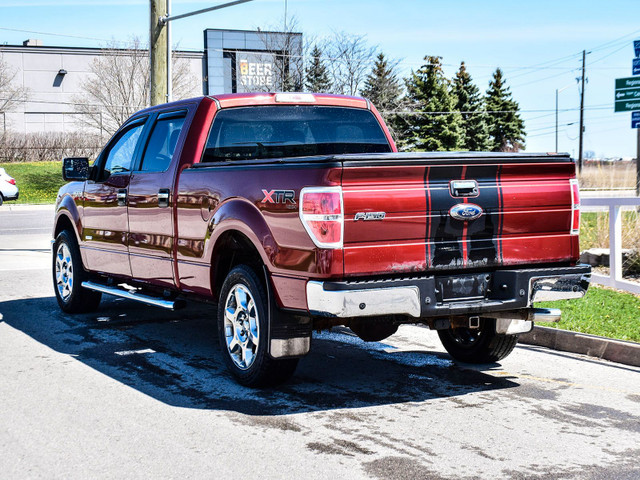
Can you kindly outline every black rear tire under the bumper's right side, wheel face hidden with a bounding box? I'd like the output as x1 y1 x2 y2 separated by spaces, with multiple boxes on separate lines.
438 318 518 363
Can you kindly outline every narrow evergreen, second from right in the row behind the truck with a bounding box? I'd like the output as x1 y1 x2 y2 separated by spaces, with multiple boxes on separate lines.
452 62 491 152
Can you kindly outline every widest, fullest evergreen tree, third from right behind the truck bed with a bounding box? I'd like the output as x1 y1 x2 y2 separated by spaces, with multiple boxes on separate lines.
402 56 463 151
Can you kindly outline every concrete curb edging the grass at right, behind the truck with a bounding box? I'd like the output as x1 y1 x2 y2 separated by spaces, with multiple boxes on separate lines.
519 325 640 367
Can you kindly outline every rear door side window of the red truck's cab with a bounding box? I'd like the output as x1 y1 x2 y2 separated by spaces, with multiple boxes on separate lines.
140 110 187 172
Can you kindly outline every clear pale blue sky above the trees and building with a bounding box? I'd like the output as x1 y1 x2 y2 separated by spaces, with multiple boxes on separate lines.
0 0 640 157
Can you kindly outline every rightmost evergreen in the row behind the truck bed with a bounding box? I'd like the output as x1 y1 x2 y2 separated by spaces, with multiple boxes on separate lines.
485 68 525 152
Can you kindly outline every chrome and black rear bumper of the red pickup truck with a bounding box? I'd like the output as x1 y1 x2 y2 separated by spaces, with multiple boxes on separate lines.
306 265 591 321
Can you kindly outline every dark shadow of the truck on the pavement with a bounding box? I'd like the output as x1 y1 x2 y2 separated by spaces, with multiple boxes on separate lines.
0 297 518 415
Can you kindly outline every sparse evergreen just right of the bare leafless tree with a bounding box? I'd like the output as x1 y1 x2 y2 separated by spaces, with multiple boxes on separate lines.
360 53 402 142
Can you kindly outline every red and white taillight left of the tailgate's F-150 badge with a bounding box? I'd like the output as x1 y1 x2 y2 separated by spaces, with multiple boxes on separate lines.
300 187 344 248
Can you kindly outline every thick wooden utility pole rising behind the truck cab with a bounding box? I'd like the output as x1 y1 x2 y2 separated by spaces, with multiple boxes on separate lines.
149 0 168 105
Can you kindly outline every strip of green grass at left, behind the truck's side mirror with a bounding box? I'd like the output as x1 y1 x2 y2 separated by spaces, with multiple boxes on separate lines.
0 162 66 204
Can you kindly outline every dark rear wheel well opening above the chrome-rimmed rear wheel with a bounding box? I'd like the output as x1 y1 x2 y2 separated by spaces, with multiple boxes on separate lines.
211 231 264 298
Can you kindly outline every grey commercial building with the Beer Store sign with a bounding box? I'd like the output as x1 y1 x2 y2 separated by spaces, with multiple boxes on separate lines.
0 29 302 133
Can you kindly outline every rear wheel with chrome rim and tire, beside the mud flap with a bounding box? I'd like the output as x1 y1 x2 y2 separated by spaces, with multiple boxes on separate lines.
218 265 298 387
